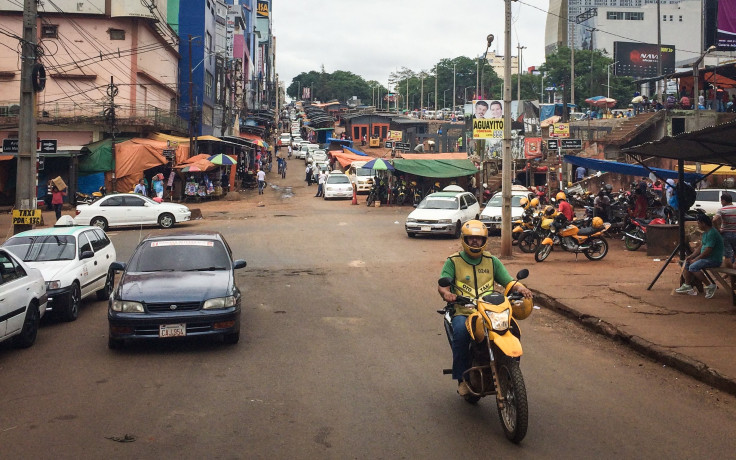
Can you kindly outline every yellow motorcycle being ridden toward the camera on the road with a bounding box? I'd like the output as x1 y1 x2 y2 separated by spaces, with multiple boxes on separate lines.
437 269 532 444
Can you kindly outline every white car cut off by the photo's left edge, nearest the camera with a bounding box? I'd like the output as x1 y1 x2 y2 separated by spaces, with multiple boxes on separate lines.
0 249 46 348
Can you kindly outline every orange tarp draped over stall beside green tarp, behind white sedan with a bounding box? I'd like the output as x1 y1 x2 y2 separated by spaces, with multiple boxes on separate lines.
105 138 170 192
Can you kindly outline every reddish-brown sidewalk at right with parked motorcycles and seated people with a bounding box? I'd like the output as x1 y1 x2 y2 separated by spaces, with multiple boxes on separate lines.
504 243 736 395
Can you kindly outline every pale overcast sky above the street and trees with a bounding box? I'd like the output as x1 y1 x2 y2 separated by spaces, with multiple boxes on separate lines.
272 0 549 87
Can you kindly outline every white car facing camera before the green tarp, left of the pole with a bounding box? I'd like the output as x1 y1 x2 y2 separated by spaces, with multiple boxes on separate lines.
405 186 480 238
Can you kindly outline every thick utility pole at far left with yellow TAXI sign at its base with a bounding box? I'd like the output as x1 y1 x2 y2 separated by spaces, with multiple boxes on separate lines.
13 0 38 228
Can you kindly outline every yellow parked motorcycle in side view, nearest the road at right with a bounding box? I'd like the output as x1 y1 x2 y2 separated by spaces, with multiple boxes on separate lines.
534 214 611 262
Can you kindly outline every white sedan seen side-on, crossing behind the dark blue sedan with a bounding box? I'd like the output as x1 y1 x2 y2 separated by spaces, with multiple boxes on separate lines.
74 193 192 230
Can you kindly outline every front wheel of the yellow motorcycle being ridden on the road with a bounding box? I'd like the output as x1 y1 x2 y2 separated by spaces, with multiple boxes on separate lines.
496 355 529 444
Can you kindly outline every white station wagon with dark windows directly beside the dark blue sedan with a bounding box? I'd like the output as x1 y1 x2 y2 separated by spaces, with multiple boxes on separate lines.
3 226 116 321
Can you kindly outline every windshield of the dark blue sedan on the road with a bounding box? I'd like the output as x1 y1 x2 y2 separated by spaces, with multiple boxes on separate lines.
128 240 232 272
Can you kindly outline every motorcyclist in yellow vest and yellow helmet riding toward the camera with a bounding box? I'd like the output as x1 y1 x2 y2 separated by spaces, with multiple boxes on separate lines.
437 220 532 396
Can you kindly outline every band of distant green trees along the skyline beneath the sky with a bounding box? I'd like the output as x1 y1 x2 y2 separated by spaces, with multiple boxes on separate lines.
286 47 634 110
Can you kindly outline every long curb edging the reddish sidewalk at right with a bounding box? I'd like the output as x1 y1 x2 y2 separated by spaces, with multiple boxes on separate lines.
532 289 736 396
